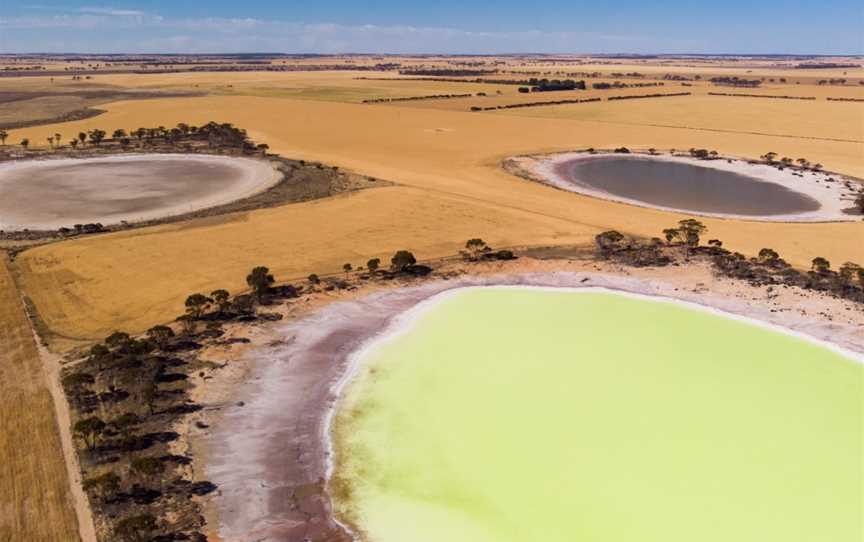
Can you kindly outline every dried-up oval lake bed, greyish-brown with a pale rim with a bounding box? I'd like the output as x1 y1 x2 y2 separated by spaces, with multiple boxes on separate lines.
0 154 281 230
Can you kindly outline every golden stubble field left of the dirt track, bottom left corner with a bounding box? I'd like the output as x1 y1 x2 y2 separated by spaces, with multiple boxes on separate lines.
0 262 78 542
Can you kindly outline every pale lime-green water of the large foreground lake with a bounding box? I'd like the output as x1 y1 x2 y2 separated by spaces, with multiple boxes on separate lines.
336 288 864 542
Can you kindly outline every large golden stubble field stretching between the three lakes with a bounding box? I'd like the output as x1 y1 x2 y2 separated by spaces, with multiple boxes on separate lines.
8 74 864 348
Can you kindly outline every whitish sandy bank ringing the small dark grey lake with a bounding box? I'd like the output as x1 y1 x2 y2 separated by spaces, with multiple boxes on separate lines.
510 152 861 222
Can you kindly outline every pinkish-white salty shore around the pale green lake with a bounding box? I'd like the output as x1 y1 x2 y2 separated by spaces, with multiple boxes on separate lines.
190 260 864 541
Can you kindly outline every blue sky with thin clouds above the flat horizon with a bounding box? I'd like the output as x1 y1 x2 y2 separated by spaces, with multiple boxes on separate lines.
0 0 864 54
